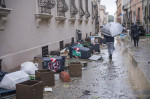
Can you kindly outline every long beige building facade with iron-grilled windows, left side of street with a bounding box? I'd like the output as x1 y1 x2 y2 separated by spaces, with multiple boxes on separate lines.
0 0 100 72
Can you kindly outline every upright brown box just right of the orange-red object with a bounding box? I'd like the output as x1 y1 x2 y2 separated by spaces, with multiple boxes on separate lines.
69 62 82 77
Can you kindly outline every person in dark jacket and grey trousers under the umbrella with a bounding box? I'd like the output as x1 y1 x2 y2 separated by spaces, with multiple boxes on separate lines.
104 35 115 60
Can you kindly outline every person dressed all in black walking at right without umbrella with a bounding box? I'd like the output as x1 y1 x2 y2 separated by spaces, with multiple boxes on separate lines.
133 25 140 47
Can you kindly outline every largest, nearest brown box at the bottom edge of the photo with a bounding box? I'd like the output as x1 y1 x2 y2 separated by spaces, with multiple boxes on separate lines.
16 80 43 99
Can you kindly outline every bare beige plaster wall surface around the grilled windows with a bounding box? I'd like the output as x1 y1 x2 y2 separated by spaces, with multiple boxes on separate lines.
0 0 94 71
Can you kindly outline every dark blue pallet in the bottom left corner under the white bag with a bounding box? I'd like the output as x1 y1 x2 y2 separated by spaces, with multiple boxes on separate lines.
0 88 16 99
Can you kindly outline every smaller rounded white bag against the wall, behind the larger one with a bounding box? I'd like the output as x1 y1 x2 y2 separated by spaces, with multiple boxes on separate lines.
21 62 38 75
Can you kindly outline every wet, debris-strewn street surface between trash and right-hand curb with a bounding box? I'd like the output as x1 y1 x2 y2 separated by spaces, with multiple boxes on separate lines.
44 37 138 99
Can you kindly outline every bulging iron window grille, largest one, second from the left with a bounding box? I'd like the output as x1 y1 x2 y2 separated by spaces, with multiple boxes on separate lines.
38 0 55 13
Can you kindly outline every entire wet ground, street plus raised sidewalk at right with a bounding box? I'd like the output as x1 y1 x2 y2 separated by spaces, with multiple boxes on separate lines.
8 37 150 99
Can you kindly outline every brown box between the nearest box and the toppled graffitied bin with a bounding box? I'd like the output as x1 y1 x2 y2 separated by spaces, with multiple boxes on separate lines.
35 69 55 87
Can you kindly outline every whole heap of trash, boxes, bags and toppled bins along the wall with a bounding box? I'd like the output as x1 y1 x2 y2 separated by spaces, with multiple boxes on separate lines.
0 33 102 99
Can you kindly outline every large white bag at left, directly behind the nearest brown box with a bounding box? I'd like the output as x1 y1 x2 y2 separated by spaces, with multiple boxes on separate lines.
0 71 30 90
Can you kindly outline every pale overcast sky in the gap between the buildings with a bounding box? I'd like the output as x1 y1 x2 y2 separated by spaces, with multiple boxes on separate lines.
101 0 117 16
